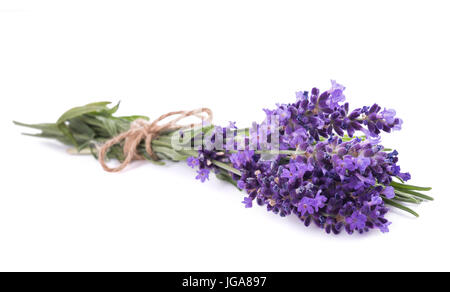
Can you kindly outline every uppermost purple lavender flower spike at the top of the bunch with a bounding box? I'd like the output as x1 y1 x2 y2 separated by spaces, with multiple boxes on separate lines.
265 80 402 146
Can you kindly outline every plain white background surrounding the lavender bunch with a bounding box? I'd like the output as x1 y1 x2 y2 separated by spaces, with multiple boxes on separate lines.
0 0 450 271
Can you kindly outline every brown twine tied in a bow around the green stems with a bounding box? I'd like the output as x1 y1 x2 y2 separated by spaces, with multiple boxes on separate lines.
98 108 213 172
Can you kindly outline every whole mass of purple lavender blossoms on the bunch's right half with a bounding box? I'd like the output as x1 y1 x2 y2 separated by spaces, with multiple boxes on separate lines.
188 81 430 234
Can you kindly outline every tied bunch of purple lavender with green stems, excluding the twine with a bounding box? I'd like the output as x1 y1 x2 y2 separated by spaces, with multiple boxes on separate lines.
16 81 433 234
